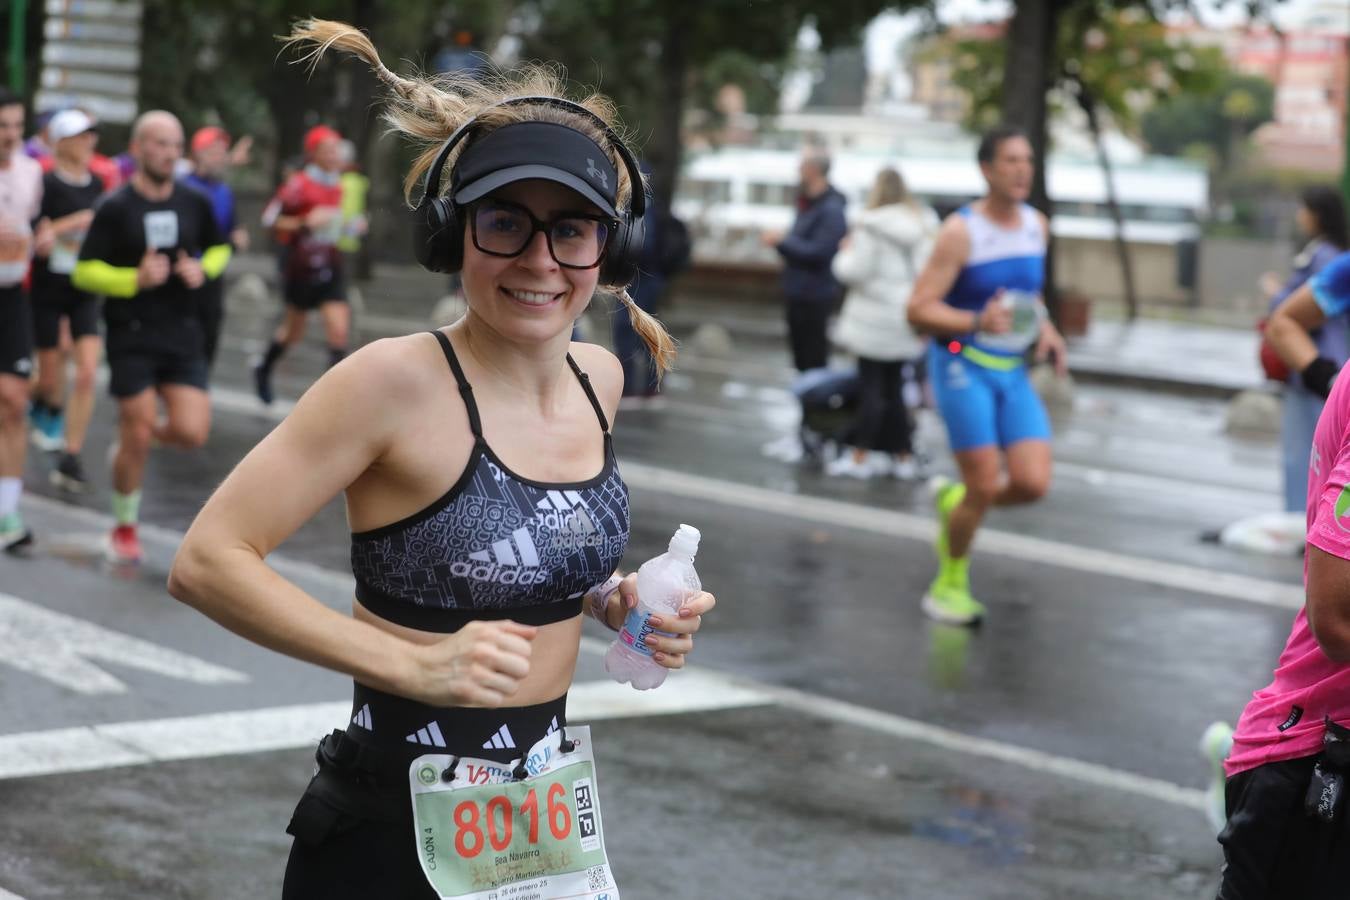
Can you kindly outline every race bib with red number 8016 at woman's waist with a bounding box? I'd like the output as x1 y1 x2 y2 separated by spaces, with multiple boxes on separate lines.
408 727 618 900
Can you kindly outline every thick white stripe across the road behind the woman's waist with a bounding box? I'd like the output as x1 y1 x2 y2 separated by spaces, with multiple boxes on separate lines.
0 671 770 780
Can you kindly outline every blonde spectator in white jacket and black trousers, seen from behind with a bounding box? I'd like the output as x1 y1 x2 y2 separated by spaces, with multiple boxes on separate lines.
826 169 938 478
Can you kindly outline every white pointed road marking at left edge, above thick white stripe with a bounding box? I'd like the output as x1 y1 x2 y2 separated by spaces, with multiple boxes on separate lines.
0 594 248 694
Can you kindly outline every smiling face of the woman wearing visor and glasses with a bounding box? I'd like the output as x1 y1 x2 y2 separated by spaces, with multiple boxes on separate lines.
460 181 599 341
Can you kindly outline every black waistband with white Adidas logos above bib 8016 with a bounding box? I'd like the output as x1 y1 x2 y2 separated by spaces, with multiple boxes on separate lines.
346 681 567 775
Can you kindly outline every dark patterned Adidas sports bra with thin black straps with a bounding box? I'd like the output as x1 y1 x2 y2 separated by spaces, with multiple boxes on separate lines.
351 331 629 631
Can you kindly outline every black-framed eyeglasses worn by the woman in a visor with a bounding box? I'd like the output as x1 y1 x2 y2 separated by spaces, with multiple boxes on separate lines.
470 200 616 269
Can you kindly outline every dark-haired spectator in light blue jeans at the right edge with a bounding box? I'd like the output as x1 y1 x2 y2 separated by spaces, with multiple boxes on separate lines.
1261 185 1350 513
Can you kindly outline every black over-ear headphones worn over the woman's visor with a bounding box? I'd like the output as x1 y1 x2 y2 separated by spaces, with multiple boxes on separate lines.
413 97 647 285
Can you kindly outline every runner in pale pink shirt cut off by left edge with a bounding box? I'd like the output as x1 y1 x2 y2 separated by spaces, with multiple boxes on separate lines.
0 88 42 553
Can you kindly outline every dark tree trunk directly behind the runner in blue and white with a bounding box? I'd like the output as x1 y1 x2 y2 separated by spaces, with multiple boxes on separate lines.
1000 0 1060 321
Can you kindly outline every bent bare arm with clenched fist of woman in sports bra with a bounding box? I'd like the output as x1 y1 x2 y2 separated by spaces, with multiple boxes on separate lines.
169 337 536 706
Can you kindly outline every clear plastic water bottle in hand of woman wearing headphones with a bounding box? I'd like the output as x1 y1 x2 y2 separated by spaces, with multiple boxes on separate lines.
605 525 702 691
